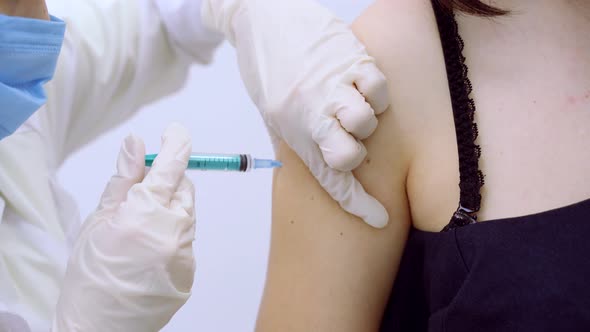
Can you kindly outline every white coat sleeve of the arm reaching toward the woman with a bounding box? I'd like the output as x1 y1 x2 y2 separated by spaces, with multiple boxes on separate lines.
40 0 221 167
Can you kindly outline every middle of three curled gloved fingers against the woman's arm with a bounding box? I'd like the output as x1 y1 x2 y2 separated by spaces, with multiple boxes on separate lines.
327 85 377 140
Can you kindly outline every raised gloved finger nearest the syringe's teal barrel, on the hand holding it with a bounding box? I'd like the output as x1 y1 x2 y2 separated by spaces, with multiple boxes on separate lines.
141 124 192 207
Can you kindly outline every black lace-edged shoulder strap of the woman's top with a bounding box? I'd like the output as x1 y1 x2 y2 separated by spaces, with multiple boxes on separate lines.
432 0 484 231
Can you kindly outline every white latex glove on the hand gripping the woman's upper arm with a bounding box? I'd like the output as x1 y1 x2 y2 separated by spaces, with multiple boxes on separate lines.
202 0 389 227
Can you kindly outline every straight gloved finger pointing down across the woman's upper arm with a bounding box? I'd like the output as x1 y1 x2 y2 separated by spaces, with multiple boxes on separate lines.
312 161 389 228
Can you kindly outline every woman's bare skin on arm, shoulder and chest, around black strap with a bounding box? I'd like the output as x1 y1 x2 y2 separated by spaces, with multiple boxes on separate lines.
257 0 590 332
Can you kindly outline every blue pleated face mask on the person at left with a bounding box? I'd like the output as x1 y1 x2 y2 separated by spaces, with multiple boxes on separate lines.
0 15 65 140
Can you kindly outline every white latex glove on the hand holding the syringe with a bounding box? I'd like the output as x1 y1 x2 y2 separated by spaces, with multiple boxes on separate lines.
52 125 195 332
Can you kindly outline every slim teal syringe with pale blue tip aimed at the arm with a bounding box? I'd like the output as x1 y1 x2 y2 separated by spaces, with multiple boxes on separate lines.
145 152 283 172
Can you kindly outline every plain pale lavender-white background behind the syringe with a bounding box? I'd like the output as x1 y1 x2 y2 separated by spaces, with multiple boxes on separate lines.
55 0 370 332
